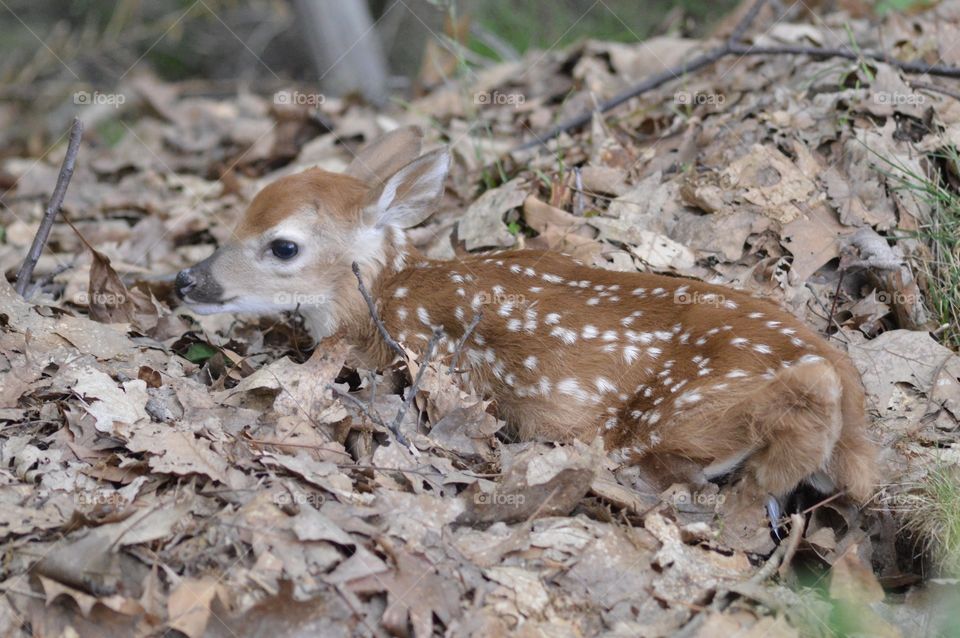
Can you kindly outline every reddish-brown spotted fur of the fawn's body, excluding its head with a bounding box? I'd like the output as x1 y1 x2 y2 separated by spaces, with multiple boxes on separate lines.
368 251 875 501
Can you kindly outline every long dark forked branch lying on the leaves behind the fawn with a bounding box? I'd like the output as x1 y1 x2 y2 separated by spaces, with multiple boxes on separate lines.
513 0 960 152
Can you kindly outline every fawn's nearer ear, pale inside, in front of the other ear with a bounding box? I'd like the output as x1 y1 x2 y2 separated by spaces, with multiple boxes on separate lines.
364 148 450 228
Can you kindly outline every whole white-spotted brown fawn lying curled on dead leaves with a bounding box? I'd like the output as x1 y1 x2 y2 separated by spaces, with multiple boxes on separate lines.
175 127 875 502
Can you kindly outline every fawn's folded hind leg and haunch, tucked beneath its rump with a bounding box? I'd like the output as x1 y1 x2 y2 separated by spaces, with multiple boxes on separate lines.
609 357 843 499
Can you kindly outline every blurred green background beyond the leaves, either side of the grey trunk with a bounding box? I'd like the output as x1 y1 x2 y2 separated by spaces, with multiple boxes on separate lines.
0 0 737 92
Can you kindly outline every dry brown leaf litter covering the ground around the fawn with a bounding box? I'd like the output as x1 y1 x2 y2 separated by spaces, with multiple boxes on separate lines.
0 2 960 638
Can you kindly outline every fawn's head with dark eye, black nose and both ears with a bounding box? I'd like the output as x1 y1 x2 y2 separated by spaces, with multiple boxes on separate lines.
175 127 450 338
